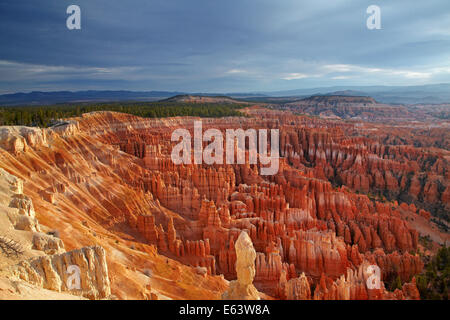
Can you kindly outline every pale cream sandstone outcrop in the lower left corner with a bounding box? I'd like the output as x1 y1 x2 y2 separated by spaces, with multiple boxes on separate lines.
0 169 111 299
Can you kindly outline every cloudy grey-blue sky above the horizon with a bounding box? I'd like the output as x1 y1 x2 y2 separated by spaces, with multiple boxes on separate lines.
0 0 450 94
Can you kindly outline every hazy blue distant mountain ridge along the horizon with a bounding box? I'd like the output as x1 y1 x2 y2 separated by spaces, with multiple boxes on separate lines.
0 84 450 106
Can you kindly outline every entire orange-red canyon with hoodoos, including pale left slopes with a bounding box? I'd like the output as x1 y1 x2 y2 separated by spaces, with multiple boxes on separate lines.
0 98 450 300
